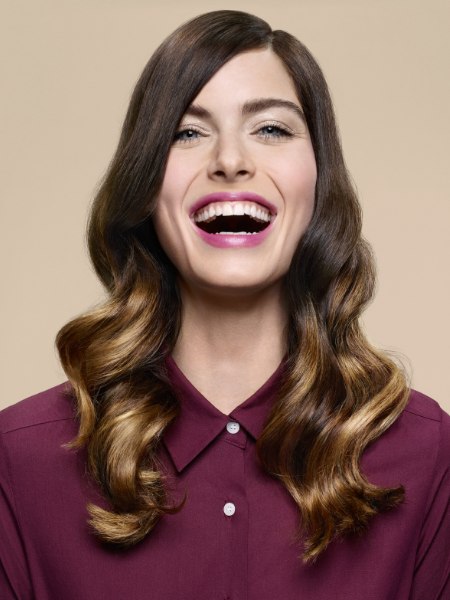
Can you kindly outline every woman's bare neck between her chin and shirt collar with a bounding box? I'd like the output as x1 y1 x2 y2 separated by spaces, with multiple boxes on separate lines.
173 285 286 414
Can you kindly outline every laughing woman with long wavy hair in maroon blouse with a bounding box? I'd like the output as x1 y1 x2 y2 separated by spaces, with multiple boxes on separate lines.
0 11 450 600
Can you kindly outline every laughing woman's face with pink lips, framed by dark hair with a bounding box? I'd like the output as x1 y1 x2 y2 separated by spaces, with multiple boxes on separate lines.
154 49 316 294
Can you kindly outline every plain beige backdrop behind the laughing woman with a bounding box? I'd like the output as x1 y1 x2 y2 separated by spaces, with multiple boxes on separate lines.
0 0 450 410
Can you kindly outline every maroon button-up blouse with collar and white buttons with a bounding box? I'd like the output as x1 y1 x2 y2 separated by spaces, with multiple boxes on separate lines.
0 361 450 600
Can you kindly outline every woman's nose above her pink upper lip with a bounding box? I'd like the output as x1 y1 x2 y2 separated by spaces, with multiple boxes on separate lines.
208 136 255 182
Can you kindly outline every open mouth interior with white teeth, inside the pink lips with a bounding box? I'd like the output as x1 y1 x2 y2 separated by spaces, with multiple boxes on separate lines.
193 202 274 235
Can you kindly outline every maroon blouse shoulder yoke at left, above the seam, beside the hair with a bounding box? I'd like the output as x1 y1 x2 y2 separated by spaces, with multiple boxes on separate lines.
0 382 76 435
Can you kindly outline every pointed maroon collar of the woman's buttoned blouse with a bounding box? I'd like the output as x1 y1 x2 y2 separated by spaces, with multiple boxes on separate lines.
163 357 283 472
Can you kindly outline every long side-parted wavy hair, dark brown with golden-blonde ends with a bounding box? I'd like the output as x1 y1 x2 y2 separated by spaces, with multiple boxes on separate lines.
57 10 409 561
